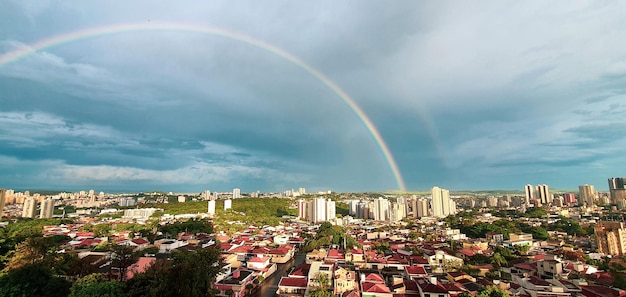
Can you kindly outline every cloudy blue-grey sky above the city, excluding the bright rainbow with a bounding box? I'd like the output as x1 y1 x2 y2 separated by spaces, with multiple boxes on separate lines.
0 0 626 192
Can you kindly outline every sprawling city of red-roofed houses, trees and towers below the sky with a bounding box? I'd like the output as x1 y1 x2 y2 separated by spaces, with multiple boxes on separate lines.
0 178 626 297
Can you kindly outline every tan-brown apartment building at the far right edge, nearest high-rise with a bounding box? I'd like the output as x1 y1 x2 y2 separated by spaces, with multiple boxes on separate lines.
595 221 626 256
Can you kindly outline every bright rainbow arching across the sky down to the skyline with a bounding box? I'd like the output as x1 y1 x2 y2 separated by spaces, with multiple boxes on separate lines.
0 22 406 192
